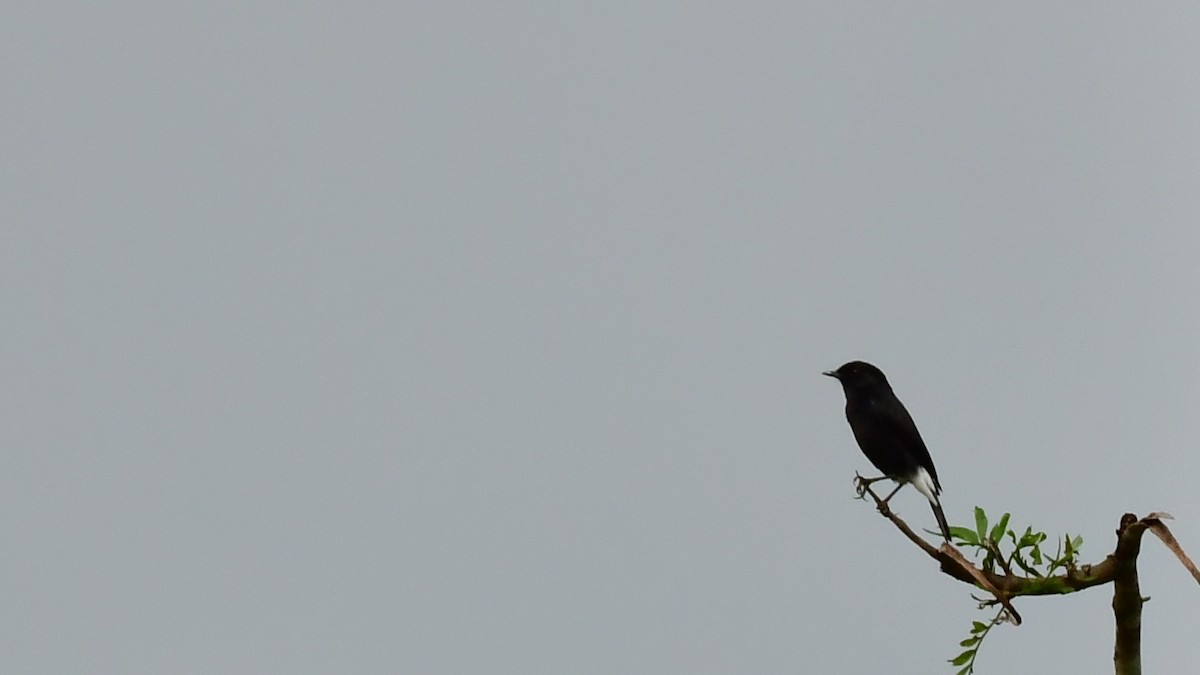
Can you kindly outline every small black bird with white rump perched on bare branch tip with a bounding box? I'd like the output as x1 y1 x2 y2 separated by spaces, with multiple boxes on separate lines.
824 362 950 542
